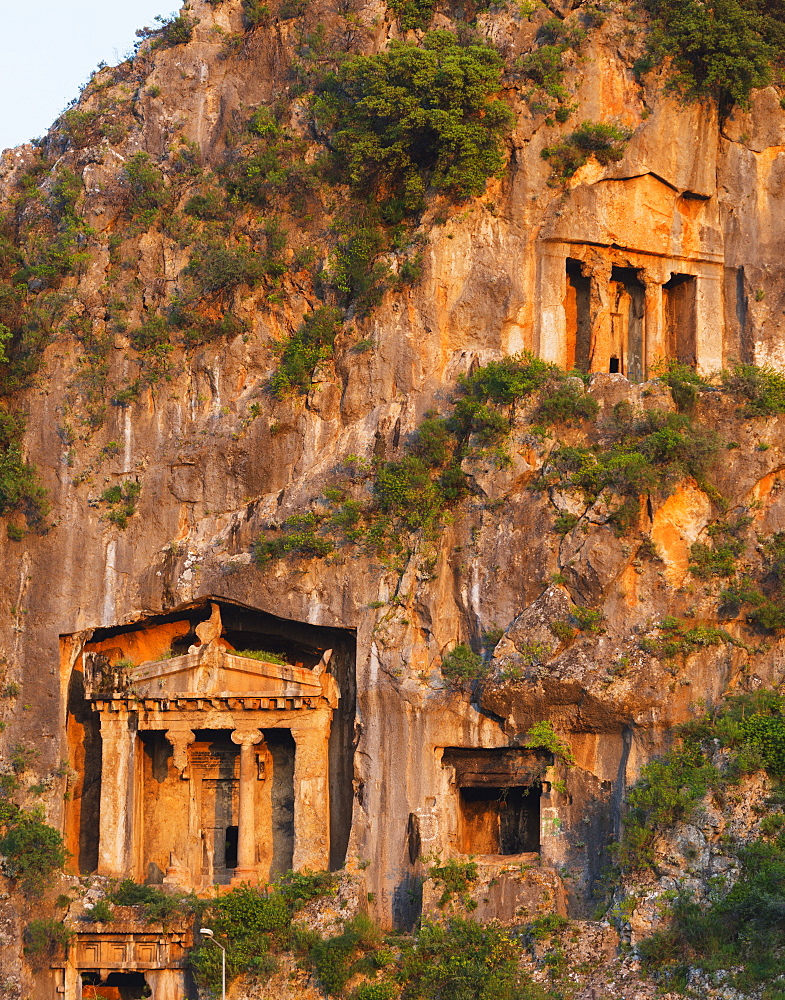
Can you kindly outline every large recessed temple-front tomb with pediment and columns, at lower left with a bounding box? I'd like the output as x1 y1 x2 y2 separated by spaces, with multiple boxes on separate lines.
61 598 356 888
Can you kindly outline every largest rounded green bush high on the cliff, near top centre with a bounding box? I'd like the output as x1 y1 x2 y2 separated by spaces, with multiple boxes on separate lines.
313 30 512 211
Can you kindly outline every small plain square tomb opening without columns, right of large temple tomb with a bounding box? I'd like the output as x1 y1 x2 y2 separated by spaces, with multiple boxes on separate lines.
442 747 551 855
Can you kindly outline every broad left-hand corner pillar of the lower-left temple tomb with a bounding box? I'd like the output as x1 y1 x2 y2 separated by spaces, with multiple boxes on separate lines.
96 708 137 878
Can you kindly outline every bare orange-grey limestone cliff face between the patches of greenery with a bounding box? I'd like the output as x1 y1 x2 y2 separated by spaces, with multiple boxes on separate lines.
0 0 785 988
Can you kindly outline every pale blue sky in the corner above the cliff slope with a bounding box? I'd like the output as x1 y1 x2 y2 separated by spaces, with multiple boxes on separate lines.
0 0 180 150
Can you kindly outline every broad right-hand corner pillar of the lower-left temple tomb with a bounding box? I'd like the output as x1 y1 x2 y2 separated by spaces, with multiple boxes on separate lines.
292 711 332 871
